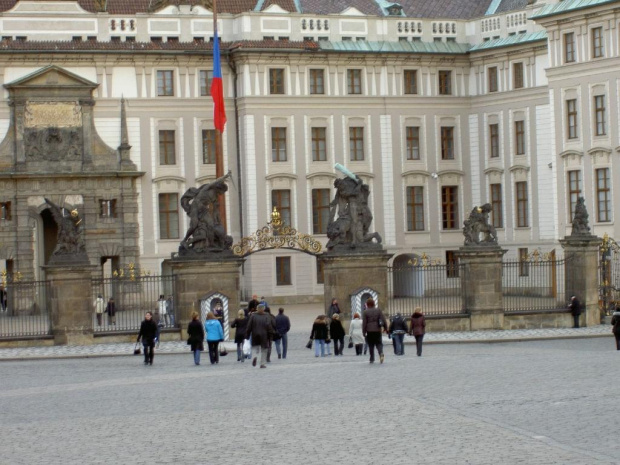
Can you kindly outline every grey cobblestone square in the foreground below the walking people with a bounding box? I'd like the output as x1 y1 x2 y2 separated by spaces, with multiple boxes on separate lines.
0 338 620 465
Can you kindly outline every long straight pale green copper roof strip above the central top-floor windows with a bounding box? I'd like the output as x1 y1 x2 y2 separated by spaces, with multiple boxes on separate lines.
319 40 469 54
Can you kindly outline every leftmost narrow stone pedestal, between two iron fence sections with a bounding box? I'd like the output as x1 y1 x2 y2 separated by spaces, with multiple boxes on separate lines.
45 263 96 345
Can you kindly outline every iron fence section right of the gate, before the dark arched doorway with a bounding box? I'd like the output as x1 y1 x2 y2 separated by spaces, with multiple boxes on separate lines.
387 264 466 315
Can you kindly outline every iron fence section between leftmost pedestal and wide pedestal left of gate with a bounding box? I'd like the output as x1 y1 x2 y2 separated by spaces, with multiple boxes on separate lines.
92 274 177 333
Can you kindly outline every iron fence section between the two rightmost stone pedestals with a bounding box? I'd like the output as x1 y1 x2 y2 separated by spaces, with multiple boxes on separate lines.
502 254 567 313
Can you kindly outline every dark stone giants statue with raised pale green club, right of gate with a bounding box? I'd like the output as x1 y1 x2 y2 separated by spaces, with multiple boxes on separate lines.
327 163 381 250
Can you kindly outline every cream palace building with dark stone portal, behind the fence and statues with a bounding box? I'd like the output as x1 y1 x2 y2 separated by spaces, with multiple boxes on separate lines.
0 0 620 302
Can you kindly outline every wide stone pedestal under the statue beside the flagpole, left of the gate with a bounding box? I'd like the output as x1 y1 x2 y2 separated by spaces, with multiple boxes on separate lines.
166 253 245 339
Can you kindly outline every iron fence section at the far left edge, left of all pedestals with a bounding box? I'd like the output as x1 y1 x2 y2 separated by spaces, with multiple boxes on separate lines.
0 275 52 339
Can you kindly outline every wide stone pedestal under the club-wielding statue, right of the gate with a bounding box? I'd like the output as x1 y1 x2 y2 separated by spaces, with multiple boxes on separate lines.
321 250 392 318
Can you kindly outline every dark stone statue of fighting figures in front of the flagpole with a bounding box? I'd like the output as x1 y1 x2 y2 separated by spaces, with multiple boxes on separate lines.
179 171 233 256
